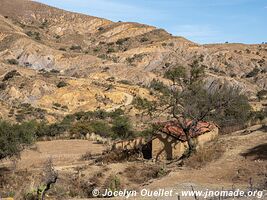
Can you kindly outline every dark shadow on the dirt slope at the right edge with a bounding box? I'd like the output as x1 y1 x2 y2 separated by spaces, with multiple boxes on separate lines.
241 143 267 160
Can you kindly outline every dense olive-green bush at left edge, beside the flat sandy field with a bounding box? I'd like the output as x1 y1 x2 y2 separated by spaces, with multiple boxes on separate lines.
0 121 36 160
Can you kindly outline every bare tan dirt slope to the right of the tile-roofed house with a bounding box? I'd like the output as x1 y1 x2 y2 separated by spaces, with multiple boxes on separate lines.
148 126 267 198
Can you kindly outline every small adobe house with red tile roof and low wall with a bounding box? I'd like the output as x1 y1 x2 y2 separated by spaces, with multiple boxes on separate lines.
113 121 219 161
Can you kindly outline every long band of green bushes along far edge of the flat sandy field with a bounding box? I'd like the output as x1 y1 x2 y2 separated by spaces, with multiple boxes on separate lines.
25 108 133 139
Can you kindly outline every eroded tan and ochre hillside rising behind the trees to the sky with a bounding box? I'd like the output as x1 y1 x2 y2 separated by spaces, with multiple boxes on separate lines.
0 0 267 121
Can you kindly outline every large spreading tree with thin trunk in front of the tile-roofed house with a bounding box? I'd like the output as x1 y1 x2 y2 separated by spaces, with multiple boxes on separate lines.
148 61 250 156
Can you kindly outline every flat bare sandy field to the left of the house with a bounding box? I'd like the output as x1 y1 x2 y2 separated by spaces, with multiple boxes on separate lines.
1 140 105 170
